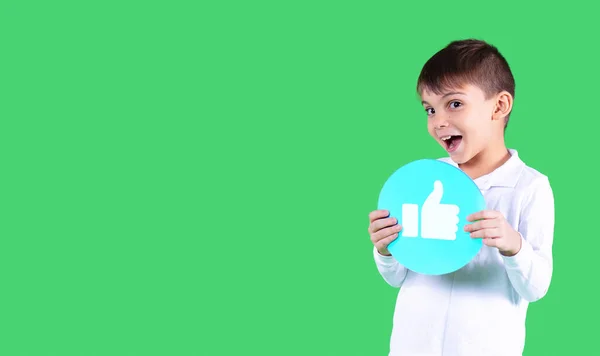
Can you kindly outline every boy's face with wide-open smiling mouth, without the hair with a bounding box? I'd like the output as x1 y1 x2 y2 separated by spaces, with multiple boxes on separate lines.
421 85 504 164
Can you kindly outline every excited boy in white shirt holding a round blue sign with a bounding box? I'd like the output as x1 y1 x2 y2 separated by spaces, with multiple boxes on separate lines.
369 39 554 356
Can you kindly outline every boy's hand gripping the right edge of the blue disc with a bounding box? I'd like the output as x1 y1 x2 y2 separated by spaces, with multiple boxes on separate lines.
465 210 521 256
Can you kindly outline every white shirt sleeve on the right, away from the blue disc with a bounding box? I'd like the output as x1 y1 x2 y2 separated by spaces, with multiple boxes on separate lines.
503 177 554 302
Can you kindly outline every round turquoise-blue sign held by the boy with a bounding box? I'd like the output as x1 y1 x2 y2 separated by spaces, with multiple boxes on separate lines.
378 159 486 275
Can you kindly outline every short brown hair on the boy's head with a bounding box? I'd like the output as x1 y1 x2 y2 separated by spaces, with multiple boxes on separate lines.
417 39 515 125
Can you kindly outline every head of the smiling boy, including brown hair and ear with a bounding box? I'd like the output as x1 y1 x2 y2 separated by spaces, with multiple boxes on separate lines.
417 39 515 163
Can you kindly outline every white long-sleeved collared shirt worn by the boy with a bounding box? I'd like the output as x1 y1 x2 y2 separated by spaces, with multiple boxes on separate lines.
373 149 554 356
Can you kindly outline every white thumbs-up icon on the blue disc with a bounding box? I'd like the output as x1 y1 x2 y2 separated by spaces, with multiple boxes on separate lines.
402 180 460 240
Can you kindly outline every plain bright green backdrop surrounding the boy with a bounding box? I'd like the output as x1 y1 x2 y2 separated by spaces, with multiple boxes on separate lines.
0 0 600 356
